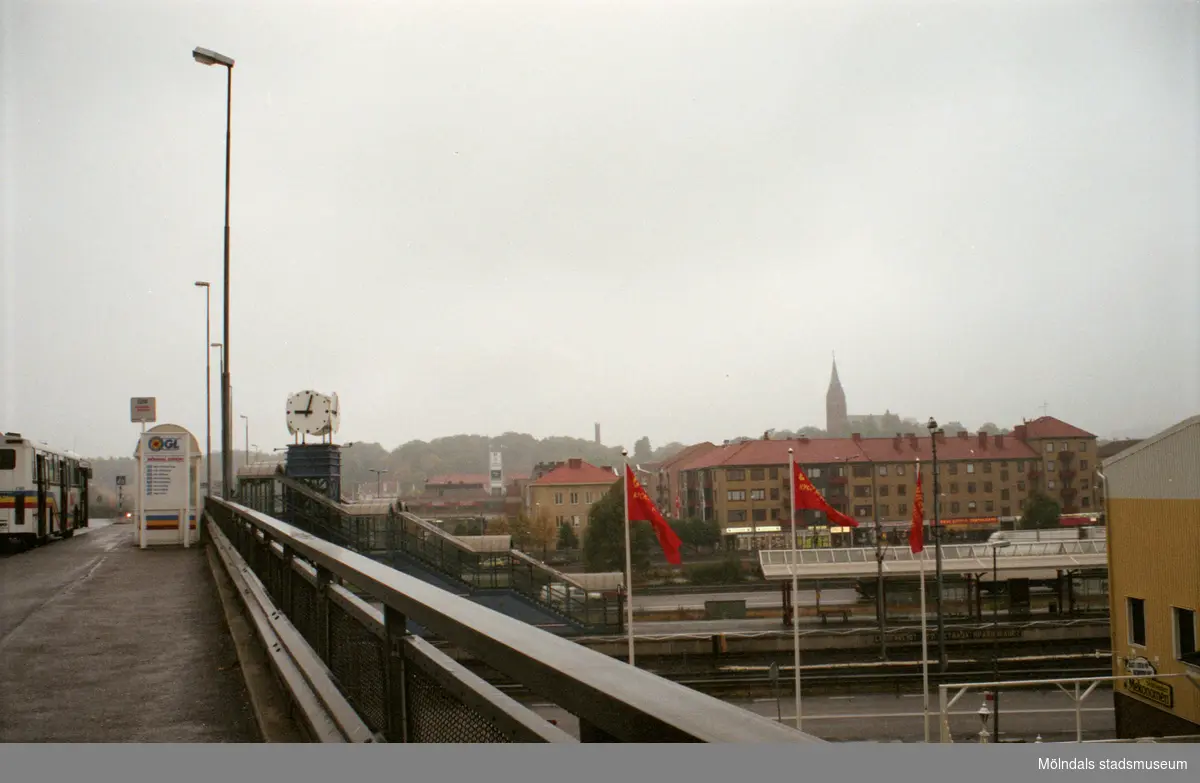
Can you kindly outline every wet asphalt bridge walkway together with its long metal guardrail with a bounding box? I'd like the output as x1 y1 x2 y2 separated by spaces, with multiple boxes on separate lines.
0 498 820 743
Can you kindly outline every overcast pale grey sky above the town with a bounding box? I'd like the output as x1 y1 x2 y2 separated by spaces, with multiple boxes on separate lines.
0 0 1200 455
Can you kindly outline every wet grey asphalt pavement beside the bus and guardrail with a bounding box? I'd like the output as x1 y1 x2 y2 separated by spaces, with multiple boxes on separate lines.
0 521 259 742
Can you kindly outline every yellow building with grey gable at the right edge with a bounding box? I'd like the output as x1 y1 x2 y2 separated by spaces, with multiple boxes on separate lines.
1104 416 1200 739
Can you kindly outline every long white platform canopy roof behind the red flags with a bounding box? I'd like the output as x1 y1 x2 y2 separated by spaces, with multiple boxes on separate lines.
758 539 1108 580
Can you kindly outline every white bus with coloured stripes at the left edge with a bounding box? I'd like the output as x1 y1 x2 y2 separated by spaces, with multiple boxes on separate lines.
0 432 91 545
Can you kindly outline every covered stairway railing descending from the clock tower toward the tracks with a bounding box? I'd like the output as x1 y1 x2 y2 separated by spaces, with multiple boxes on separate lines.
244 473 625 634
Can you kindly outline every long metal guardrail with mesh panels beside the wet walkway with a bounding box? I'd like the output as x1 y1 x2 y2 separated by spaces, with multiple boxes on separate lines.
205 497 821 743
